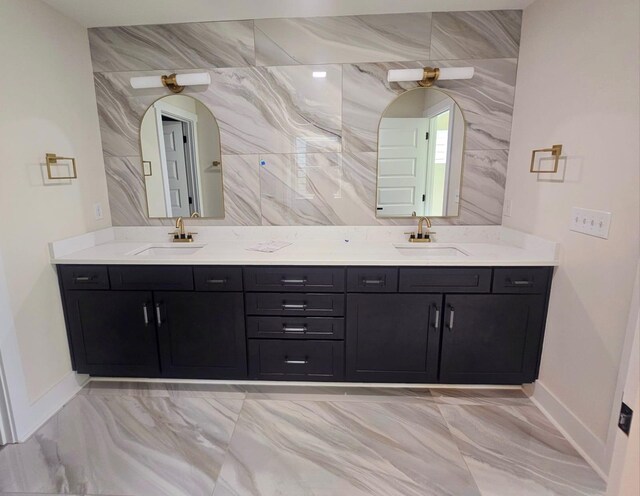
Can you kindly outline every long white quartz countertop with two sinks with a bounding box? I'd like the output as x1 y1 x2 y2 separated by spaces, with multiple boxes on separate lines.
50 226 558 266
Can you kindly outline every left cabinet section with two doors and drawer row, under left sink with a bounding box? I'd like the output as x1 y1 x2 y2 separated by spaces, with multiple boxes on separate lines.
59 265 247 379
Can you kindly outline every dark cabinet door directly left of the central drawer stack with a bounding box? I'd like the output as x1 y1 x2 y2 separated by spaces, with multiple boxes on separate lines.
154 292 247 379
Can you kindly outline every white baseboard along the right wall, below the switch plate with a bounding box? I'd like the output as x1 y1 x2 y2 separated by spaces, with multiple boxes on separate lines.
531 381 607 481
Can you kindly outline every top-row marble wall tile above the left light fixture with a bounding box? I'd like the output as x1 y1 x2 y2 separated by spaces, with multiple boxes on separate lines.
89 21 255 72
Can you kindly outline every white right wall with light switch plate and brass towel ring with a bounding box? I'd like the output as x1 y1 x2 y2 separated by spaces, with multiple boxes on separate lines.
504 0 640 472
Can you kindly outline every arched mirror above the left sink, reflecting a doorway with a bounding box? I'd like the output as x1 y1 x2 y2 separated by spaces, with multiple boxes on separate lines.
140 95 224 219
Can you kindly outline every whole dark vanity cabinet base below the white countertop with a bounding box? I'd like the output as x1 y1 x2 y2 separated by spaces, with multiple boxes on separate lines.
58 265 552 384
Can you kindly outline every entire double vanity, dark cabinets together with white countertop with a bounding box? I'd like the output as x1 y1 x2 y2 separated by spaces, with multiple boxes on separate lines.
51 226 557 384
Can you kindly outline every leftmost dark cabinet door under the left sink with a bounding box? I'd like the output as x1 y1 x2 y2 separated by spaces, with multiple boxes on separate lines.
65 291 160 377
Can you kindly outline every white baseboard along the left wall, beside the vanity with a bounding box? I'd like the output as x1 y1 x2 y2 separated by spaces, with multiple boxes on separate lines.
14 371 89 443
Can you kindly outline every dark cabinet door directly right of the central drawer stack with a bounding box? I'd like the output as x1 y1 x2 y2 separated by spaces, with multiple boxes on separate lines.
346 294 442 382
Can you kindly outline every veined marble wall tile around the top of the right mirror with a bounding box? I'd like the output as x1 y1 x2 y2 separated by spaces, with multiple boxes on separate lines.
342 59 517 152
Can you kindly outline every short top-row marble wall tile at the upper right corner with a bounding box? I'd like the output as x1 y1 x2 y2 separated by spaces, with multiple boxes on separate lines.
431 10 522 59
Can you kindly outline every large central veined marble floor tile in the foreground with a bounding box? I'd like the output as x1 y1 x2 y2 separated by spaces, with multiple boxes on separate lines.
214 400 480 496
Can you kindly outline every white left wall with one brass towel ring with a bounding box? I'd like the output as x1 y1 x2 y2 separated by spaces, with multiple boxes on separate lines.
0 0 110 412
